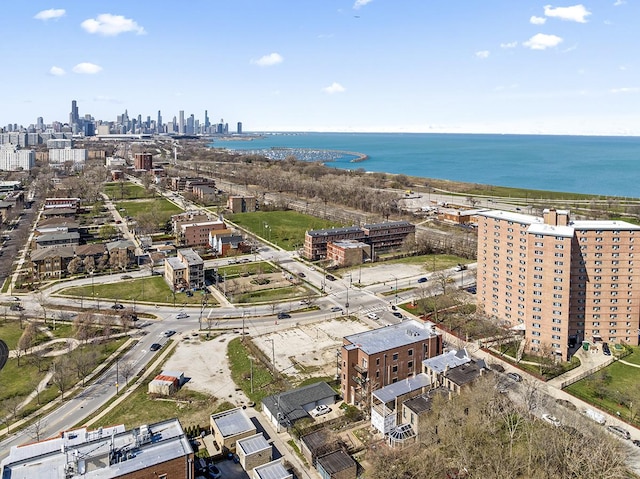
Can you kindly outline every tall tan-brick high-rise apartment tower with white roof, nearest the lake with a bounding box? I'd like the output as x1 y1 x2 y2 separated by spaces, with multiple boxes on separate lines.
477 209 640 359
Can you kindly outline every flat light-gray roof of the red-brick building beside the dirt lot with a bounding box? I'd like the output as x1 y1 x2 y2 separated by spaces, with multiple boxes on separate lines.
344 319 439 355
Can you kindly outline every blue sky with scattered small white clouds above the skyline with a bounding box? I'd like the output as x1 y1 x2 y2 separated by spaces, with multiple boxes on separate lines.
0 0 640 135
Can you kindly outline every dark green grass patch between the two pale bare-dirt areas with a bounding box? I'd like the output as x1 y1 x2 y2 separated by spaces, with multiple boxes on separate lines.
227 338 285 407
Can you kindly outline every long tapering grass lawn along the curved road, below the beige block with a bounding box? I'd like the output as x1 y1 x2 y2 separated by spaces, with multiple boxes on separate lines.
60 276 215 308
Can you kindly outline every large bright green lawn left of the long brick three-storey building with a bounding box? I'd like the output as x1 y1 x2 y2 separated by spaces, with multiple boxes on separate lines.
227 211 342 251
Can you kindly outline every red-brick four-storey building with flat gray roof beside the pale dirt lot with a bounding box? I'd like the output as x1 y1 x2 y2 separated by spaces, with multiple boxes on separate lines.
340 320 442 408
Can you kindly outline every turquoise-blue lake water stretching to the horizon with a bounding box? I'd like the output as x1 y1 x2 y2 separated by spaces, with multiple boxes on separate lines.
213 133 640 197
